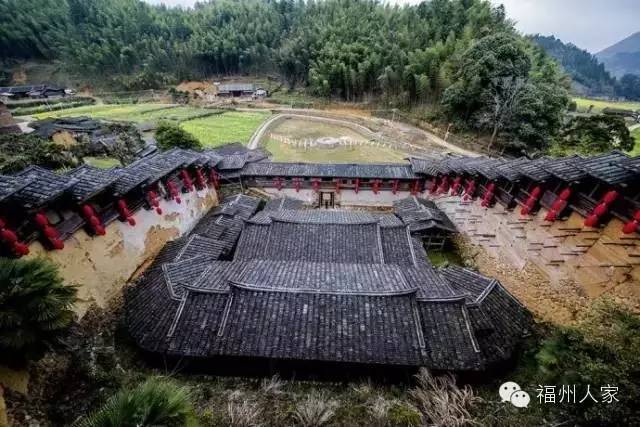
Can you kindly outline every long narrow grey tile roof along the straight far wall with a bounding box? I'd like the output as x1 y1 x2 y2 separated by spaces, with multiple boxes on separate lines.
242 162 416 179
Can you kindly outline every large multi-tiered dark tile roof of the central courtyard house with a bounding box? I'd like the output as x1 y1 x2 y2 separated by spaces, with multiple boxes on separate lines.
126 198 529 370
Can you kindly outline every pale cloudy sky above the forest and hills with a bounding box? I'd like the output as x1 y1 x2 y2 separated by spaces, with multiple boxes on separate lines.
145 0 640 53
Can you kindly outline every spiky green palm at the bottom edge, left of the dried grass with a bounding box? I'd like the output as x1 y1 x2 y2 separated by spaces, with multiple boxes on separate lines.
76 378 196 427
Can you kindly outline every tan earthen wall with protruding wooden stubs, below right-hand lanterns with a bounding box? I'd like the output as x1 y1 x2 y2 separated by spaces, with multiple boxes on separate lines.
435 196 640 311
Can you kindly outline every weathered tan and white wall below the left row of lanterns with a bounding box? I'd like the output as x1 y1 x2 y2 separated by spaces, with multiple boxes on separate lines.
29 188 218 316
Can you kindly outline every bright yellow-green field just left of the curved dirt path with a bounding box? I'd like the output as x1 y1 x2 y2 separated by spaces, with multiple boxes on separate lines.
181 111 270 147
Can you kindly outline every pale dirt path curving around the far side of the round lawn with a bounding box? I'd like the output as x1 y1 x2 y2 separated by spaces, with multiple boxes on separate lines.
248 109 478 156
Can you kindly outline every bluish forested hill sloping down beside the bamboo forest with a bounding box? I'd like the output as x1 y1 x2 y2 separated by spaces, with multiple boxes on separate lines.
530 34 616 96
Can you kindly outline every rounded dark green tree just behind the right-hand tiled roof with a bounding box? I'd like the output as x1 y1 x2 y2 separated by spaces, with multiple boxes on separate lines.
559 115 635 155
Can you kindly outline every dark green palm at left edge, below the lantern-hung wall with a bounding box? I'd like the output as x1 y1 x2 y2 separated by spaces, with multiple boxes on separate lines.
0 258 77 362
